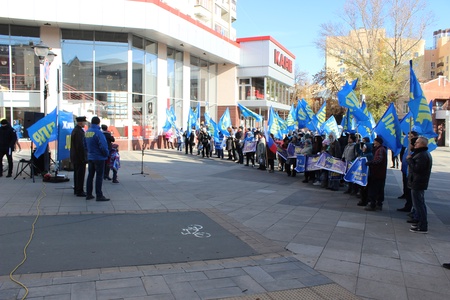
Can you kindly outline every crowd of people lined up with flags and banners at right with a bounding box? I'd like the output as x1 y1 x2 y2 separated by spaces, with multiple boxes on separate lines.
164 124 432 233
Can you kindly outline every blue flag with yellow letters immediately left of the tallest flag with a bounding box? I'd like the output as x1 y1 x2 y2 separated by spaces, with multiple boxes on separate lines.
374 103 402 156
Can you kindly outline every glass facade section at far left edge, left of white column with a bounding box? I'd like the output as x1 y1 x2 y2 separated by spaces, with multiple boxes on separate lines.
0 24 40 124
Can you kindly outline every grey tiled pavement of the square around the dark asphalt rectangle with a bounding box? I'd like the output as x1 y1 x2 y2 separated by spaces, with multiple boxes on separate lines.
0 148 450 300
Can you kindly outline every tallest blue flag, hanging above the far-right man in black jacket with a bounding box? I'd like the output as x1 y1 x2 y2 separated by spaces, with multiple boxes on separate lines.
408 60 437 138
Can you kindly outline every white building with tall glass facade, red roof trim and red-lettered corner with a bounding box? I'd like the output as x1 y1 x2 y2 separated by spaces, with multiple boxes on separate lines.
0 0 295 149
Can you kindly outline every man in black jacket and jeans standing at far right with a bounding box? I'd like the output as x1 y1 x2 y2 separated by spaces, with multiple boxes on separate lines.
406 137 433 233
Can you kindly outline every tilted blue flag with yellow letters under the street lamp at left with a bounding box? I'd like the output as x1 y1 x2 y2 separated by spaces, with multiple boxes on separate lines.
28 108 57 158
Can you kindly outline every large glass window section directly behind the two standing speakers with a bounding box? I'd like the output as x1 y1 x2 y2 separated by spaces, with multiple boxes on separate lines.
61 29 158 138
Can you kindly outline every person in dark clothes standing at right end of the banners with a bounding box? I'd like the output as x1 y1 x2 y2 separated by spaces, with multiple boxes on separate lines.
365 136 387 211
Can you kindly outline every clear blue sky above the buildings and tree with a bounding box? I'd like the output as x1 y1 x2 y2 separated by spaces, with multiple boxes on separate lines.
233 0 450 77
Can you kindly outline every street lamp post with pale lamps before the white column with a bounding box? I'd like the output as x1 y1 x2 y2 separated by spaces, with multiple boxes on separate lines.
32 41 56 171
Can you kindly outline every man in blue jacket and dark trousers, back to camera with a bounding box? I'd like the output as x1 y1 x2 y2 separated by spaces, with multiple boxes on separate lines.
84 117 109 201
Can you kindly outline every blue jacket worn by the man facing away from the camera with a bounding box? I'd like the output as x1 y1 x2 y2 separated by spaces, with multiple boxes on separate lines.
84 124 109 160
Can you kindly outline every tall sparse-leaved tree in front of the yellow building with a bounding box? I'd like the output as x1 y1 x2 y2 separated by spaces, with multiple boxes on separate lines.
316 0 432 116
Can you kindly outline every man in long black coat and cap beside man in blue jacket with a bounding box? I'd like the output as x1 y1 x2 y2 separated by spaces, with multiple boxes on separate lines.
70 117 87 197
